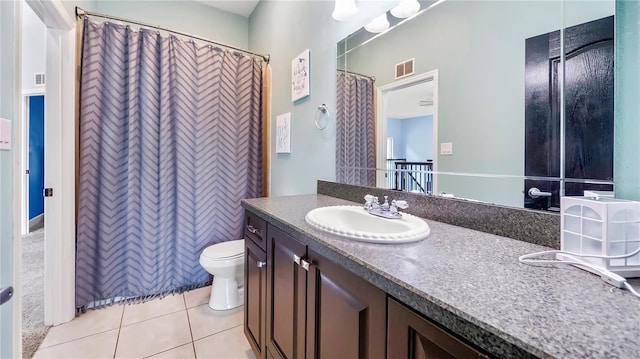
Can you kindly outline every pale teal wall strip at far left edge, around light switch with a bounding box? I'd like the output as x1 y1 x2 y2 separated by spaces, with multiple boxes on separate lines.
0 1 20 358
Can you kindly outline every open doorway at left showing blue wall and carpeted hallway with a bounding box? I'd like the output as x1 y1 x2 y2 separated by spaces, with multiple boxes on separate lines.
20 3 48 358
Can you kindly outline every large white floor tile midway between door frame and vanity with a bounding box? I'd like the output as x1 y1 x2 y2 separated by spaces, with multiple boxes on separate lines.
115 310 191 358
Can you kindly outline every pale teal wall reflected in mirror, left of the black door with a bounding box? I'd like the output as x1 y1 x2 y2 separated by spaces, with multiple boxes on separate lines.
310 0 614 206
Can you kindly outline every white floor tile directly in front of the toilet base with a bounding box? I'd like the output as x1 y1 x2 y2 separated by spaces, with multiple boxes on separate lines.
187 304 244 340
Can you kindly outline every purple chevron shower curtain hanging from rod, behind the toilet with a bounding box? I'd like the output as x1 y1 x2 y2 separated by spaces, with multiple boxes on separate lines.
76 19 263 307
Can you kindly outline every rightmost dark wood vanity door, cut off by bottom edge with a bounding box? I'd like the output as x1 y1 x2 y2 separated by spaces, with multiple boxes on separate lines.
387 299 487 359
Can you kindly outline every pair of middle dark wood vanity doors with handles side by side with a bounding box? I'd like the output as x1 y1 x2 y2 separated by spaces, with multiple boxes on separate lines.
267 226 386 359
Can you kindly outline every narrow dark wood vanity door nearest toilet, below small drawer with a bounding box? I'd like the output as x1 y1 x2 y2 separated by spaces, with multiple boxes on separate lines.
244 240 267 359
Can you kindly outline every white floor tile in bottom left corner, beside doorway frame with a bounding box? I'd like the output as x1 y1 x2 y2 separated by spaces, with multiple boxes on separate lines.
34 329 118 359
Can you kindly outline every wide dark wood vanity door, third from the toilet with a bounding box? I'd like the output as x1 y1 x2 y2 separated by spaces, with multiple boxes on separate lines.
303 250 386 359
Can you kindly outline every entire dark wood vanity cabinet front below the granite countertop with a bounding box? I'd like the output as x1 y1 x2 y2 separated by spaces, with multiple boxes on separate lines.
244 212 485 359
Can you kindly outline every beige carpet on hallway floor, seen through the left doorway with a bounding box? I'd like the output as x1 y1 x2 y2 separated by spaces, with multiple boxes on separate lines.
22 228 49 359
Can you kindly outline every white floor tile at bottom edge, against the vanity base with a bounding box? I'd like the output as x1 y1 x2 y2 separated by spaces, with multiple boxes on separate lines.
194 327 255 359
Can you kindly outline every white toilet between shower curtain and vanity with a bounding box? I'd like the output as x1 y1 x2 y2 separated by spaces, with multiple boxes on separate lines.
200 239 244 310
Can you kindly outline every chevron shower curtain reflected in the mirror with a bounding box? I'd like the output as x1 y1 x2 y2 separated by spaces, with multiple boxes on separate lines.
336 71 376 186
